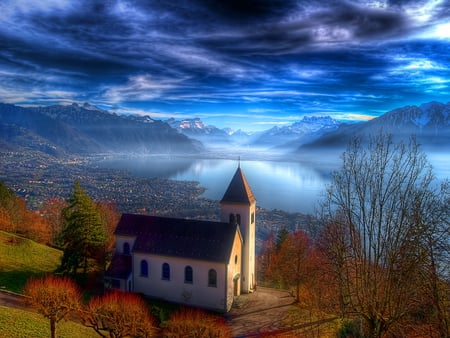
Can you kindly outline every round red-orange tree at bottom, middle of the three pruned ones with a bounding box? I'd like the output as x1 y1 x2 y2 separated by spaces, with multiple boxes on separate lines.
82 291 157 338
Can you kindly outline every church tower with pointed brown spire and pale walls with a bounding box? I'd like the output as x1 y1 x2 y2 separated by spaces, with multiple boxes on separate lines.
220 165 256 293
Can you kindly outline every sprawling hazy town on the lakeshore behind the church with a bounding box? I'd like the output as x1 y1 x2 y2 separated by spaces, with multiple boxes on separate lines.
0 151 319 248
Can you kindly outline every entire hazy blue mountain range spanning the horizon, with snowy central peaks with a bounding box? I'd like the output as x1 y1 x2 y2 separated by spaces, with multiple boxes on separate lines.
0 102 450 157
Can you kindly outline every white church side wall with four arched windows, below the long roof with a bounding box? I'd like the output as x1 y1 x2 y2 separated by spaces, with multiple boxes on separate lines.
133 253 226 311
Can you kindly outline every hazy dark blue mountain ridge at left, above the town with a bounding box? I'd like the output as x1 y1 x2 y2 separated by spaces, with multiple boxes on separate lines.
0 103 202 156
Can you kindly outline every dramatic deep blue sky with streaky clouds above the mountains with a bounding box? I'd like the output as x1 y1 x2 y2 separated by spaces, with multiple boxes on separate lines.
0 0 450 131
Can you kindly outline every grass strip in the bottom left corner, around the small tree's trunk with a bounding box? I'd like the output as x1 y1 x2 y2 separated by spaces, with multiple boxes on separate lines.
0 306 98 338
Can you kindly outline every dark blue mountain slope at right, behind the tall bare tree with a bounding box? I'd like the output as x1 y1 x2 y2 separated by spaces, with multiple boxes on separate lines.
297 102 450 153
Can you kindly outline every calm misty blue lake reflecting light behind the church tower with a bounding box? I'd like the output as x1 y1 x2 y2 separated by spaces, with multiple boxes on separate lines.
96 154 450 214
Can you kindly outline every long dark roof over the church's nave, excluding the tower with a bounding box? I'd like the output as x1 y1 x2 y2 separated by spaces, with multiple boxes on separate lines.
115 214 237 263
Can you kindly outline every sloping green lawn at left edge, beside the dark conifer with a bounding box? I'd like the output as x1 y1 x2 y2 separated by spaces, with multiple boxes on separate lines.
0 231 62 293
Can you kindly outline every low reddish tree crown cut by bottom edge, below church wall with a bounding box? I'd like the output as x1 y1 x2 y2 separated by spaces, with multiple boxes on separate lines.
163 308 231 338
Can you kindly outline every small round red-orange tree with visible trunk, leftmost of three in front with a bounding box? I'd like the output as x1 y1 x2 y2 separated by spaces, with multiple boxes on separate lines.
24 276 81 338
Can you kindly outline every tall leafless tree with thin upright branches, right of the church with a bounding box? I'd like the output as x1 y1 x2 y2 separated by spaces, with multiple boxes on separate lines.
323 134 450 337
